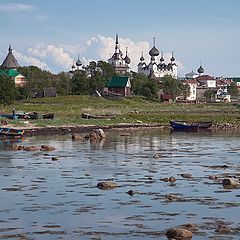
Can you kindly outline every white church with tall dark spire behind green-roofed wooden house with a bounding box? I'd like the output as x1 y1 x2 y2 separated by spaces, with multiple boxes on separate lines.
108 34 131 75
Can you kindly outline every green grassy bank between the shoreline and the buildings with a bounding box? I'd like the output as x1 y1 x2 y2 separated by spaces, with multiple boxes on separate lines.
0 96 240 127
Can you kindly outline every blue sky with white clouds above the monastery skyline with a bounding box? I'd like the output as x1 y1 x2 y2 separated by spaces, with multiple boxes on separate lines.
0 0 240 77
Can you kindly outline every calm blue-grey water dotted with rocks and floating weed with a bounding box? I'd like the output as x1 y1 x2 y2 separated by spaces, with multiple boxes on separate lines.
0 130 240 240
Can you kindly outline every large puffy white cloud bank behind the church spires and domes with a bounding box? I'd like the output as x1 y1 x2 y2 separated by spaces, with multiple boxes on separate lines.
7 34 183 73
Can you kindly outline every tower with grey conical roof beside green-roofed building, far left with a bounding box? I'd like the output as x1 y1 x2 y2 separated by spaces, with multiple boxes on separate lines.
0 45 27 86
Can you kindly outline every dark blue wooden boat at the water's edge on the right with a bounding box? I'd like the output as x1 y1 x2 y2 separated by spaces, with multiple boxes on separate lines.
170 120 212 130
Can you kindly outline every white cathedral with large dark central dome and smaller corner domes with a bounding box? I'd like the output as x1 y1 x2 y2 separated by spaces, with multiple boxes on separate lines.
138 38 178 78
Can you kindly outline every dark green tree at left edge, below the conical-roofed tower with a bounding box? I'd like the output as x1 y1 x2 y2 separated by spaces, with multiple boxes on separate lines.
0 75 17 105
